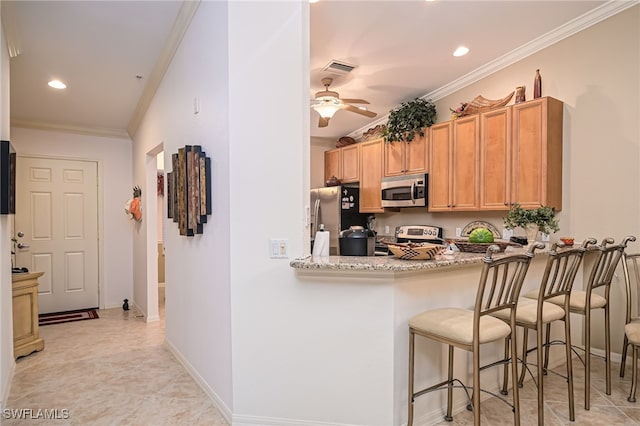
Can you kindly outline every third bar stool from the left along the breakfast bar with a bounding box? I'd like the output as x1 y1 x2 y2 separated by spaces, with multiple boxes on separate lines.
548 236 636 410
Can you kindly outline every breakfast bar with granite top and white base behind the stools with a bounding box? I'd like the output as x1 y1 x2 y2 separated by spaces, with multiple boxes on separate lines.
290 249 564 426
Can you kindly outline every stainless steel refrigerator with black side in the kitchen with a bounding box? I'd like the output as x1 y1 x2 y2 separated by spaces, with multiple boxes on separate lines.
310 186 369 255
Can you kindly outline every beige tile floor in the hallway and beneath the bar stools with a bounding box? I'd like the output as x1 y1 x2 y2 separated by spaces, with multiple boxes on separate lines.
6 288 640 426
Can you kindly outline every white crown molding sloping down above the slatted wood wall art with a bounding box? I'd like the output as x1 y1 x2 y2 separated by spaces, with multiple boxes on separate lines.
127 0 200 138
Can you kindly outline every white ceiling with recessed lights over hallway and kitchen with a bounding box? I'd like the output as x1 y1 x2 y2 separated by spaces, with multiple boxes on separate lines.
2 0 628 139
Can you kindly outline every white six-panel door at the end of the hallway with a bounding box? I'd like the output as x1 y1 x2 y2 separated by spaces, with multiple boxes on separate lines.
15 156 99 313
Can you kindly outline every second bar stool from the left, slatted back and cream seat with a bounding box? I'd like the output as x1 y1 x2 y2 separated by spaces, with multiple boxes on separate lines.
494 238 596 425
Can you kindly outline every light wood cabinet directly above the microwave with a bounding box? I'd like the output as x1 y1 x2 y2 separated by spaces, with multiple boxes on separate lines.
384 128 429 177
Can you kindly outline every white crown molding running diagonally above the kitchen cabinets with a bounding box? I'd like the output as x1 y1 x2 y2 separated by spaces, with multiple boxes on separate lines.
348 0 640 139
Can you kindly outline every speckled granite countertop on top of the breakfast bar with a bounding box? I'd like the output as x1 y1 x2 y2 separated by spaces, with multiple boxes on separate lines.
289 249 542 272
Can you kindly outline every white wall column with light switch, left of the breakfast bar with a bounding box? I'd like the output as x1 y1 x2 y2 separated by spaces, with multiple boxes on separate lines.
228 1 312 424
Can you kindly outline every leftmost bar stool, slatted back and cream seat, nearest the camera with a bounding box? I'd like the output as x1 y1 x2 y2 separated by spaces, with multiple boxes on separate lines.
407 243 544 426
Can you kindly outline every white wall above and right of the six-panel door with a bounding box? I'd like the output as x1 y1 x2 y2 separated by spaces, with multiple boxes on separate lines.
11 127 134 308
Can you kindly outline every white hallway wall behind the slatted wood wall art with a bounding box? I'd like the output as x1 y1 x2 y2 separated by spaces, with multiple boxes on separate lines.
134 2 234 416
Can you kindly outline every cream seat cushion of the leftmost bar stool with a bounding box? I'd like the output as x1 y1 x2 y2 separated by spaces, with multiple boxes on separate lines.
409 308 511 345
